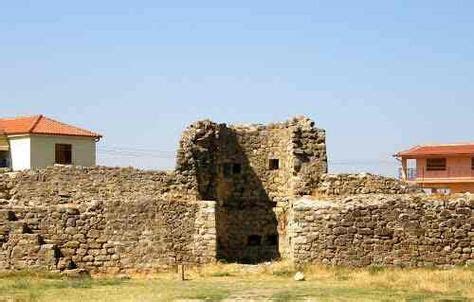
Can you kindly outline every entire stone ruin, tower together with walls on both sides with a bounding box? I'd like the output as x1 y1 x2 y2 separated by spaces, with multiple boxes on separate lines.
0 117 474 273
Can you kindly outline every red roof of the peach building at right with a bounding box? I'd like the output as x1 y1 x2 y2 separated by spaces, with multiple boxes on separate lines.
395 143 474 157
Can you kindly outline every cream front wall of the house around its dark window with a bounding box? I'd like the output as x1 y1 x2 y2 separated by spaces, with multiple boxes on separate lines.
31 135 96 169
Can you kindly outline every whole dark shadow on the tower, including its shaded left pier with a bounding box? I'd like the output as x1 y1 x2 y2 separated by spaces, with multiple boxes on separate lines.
187 124 280 263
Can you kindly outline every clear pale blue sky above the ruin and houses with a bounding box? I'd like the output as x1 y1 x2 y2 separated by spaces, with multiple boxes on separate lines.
0 0 474 175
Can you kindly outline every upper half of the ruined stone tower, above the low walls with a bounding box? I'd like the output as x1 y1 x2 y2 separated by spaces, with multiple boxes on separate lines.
177 117 327 204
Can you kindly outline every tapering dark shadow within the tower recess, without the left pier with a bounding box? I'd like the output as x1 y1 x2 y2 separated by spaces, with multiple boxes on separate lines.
216 128 280 263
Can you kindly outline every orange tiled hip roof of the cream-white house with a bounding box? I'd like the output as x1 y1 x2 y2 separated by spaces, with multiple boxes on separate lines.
0 115 102 139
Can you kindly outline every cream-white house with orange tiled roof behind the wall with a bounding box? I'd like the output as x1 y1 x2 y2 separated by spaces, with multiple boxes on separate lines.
0 115 102 171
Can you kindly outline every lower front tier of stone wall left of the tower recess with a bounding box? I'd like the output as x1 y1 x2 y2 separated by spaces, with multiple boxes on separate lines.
0 200 216 273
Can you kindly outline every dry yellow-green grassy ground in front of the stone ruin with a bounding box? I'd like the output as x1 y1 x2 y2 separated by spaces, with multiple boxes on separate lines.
0 263 474 302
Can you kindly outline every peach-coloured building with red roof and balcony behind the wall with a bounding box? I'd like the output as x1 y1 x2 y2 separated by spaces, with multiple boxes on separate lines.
395 143 474 193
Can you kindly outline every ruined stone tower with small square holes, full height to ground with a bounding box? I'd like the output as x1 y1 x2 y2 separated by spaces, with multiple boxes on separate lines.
177 117 327 263
